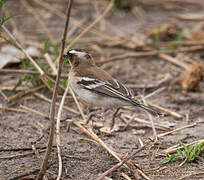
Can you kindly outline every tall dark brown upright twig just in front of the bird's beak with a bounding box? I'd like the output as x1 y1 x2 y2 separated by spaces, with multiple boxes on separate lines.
37 0 72 180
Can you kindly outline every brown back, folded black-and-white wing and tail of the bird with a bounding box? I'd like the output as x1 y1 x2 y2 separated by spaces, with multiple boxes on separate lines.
74 66 160 115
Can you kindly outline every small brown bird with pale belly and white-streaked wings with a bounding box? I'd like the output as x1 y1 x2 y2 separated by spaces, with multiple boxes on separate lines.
63 49 161 124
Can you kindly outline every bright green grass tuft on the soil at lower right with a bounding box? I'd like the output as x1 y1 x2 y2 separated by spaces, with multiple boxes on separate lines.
161 141 204 166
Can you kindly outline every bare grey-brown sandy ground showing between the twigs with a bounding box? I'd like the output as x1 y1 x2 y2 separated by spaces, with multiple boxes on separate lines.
0 1 204 180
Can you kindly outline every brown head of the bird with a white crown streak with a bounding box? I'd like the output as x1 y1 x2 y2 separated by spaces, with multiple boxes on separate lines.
64 49 95 67
